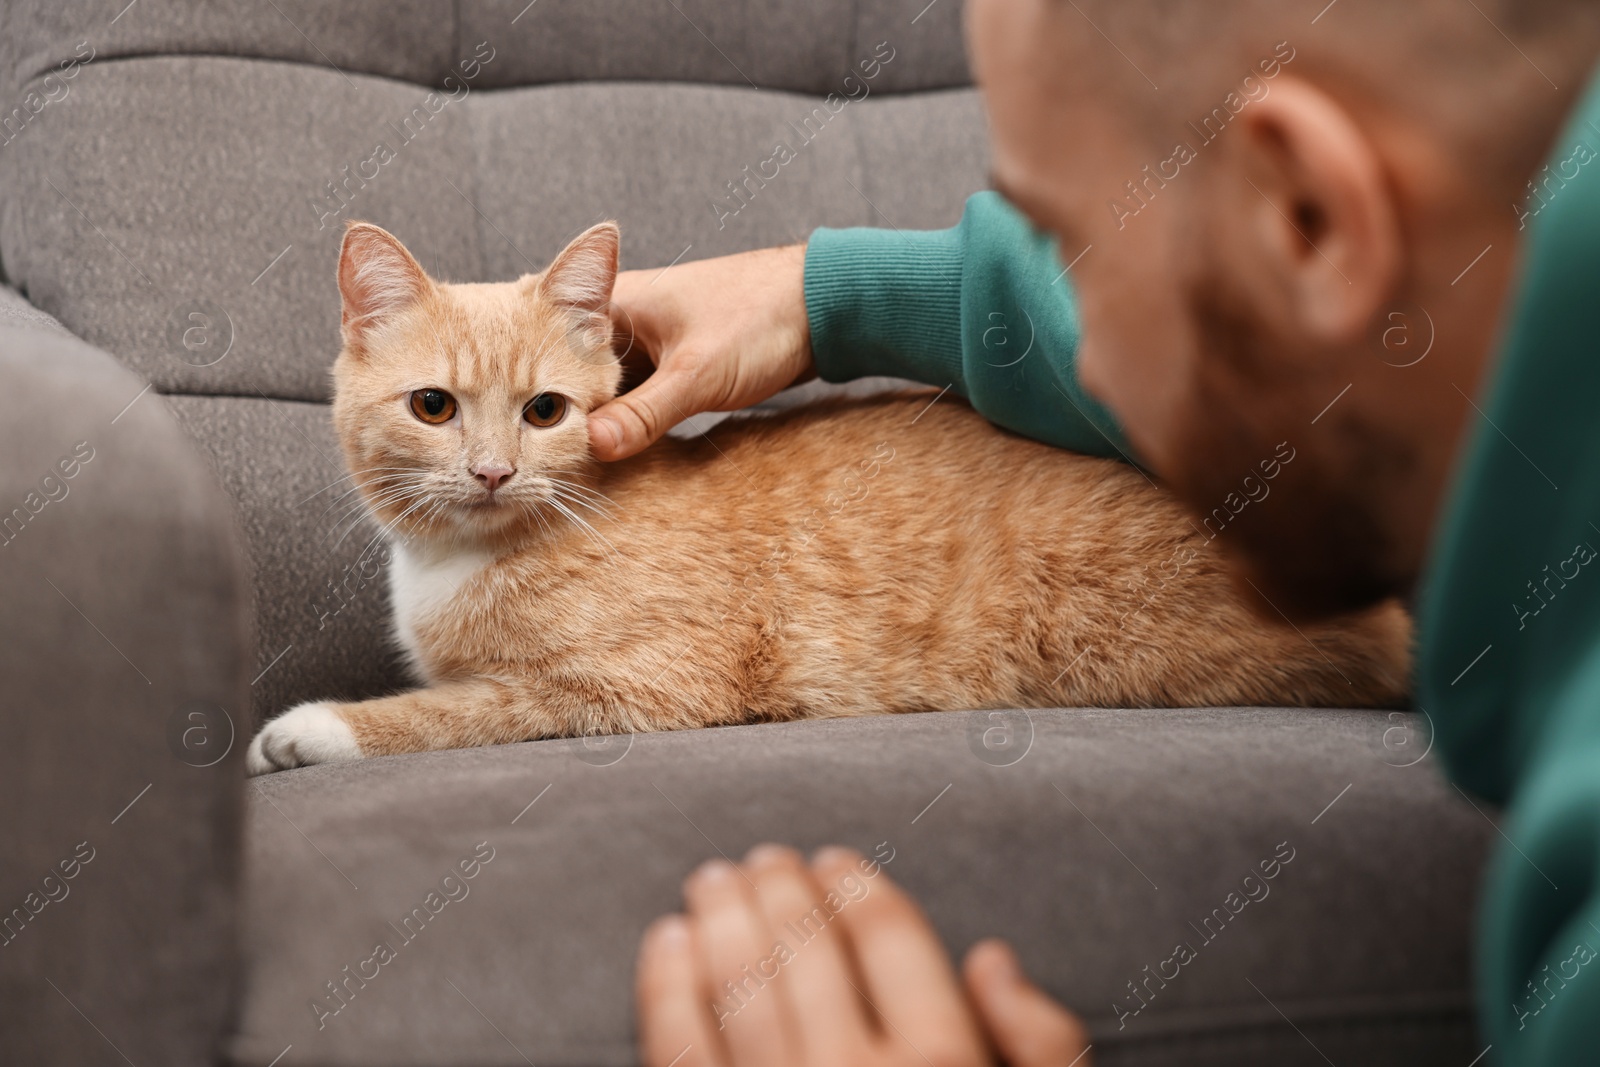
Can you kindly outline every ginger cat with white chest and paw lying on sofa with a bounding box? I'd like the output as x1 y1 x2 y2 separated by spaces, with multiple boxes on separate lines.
248 222 1411 774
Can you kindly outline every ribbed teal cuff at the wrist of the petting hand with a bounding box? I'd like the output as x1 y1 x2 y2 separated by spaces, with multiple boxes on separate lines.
805 229 965 394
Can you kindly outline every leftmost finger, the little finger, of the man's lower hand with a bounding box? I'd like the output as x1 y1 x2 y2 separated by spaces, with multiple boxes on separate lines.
635 915 726 1067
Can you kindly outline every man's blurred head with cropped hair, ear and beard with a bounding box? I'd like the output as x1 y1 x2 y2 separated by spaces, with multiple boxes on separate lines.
968 0 1600 616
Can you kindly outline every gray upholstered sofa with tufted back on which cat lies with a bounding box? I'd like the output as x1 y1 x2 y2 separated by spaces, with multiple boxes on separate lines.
0 0 1494 1067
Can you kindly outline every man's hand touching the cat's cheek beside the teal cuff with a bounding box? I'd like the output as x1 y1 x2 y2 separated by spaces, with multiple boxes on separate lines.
589 245 814 459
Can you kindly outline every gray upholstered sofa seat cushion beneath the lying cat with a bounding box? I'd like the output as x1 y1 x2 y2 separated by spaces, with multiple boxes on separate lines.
234 709 1494 1067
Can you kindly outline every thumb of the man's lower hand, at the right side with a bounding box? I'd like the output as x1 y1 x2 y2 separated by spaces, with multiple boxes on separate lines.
962 939 1090 1067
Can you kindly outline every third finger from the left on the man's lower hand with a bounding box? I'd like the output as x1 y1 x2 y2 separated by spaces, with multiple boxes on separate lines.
744 845 872 1064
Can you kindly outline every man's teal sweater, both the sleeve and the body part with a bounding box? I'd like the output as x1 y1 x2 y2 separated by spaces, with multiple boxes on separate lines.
805 78 1600 1067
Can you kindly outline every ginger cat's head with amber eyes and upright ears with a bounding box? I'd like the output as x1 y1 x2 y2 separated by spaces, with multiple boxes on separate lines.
333 222 621 541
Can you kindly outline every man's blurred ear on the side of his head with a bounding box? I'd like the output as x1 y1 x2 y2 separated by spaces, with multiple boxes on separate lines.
1238 75 1403 344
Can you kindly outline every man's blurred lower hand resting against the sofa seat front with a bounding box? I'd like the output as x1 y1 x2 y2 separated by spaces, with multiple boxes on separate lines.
637 845 1088 1067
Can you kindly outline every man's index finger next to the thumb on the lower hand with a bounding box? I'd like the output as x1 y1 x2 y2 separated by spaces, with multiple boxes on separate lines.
811 848 984 1062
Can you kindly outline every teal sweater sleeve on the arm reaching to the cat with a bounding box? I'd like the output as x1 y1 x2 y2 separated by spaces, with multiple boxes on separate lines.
805 192 1134 461
